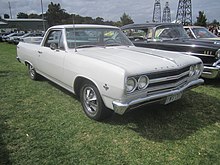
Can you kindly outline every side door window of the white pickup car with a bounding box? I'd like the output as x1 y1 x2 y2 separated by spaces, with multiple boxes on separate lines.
44 30 65 50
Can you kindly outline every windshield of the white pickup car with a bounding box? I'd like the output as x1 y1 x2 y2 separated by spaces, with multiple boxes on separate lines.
66 28 133 48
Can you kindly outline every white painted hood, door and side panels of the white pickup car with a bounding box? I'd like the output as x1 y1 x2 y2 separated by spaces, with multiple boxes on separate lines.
17 26 204 112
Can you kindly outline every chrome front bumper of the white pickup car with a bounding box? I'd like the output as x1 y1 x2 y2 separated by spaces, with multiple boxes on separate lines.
112 79 204 115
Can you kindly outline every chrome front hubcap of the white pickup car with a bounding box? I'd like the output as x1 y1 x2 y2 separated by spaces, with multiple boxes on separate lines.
83 87 98 115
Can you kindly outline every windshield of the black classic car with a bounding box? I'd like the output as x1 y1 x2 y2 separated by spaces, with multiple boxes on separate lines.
155 26 189 40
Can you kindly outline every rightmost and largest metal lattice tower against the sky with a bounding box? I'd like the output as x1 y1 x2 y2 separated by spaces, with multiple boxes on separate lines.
176 0 192 25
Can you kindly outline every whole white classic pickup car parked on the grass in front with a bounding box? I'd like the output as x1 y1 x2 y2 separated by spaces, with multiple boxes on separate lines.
17 24 204 120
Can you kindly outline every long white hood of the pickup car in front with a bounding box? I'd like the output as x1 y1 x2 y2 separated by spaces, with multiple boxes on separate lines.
77 46 201 74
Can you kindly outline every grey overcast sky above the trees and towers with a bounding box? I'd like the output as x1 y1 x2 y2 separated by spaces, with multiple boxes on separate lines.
0 0 220 23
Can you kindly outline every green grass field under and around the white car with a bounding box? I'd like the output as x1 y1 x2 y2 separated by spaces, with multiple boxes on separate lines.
0 43 220 165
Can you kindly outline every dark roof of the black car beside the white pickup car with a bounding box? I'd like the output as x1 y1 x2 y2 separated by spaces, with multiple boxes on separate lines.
121 23 182 30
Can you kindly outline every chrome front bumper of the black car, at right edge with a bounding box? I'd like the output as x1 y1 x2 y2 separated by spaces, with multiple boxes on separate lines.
201 65 220 79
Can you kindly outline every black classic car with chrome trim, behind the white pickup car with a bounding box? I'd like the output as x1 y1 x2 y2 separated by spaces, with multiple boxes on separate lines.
121 23 220 79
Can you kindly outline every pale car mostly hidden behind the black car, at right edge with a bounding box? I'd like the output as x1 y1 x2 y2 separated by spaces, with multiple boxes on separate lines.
184 26 220 44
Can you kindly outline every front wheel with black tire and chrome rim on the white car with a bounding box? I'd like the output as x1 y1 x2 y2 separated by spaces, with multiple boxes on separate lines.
80 82 112 121
